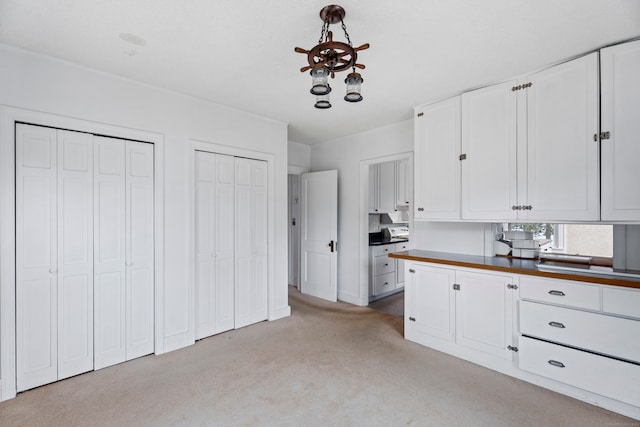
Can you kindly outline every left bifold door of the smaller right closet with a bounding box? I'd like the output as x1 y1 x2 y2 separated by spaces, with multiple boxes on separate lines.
195 151 235 339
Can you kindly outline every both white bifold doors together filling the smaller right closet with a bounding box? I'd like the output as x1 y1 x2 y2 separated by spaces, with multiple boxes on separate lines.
195 151 267 339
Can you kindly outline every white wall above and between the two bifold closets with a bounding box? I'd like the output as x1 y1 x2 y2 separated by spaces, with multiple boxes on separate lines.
0 45 290 402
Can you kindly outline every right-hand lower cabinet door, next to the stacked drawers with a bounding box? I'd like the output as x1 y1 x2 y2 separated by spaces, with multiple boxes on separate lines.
456 271 513 360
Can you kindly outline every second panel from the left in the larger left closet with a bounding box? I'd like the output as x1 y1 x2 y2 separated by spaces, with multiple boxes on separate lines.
57 131 93 379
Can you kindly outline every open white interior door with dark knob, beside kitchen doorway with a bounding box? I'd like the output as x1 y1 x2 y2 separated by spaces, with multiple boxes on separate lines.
300 170 338 301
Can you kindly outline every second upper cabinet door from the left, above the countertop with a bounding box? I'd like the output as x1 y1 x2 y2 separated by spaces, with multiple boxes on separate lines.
461 81 518 220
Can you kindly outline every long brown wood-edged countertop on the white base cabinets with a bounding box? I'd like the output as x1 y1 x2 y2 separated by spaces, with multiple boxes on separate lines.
389 249 640 289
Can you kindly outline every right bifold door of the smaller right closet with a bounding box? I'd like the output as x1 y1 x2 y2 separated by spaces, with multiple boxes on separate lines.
235 158 268 328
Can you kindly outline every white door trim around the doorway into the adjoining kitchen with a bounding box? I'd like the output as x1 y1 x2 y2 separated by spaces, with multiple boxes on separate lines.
358 151 413 306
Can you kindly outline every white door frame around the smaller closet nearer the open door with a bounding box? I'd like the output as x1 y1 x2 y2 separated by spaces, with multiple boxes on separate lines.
187 139 282 342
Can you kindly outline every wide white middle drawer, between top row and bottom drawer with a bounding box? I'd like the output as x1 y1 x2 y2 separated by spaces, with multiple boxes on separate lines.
520 301 640 362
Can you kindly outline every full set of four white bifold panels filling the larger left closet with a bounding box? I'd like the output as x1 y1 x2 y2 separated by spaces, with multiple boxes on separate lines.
16 124 154 391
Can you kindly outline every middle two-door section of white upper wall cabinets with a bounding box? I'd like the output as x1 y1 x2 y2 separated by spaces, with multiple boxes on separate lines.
461 53 600 221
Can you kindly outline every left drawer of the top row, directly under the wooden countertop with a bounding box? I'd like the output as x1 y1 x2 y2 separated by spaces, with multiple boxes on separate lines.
520 276 600 311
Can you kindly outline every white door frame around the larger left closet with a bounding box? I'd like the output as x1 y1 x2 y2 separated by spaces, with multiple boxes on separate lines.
0 105 164 402
